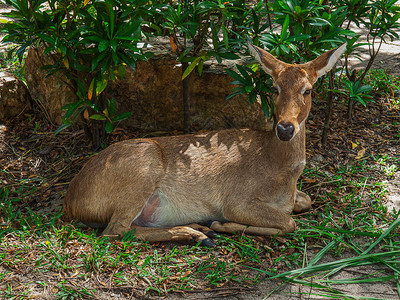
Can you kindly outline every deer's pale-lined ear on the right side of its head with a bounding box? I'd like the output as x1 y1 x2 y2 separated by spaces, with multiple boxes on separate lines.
303 43 347 81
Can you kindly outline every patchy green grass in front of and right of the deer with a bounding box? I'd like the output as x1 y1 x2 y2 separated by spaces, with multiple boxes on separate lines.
0 150 400 299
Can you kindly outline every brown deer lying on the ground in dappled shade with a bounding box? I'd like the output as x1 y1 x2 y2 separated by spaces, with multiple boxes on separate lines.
64 44 346 246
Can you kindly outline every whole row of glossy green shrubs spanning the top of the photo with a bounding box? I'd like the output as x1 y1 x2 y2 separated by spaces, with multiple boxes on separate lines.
2 0 400 146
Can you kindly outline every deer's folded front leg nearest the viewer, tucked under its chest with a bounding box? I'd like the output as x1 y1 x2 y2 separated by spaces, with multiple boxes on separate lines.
217 199 296 235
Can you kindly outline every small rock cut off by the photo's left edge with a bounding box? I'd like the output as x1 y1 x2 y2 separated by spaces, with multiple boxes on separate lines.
0 72 32 119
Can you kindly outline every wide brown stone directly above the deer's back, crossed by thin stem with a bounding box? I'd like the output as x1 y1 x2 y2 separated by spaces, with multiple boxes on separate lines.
112 59 264 130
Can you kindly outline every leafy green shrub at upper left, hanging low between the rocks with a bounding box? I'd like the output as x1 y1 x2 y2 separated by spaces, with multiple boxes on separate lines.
2 0 147 147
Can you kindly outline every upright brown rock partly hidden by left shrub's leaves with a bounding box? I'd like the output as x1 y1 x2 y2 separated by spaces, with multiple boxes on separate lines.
25 48 76 124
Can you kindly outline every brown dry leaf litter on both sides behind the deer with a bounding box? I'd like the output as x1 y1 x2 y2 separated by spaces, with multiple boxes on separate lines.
0 92 400 219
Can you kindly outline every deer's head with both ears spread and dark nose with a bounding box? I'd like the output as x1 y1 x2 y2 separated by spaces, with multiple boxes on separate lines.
249 43 346 141
